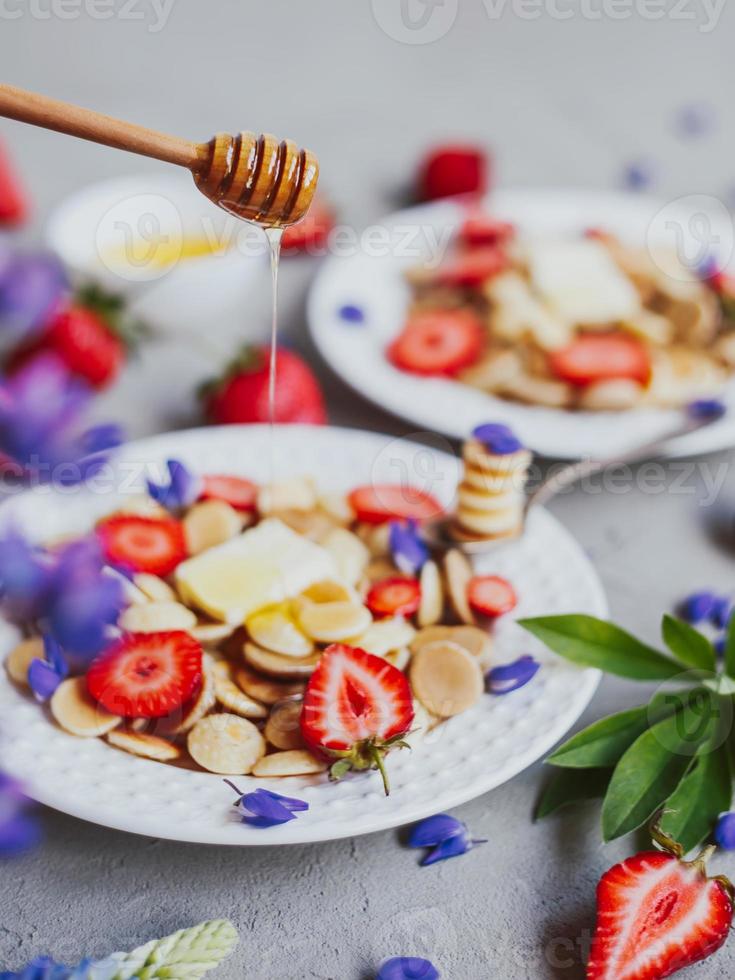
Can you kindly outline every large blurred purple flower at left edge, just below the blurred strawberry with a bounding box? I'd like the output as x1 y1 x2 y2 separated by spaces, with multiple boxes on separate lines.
0 354 122 486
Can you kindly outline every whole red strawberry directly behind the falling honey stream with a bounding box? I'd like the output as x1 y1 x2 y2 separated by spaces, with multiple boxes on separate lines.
203 347 327 425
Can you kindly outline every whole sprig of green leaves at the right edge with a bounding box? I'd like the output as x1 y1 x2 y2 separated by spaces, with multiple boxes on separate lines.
521 615 735 851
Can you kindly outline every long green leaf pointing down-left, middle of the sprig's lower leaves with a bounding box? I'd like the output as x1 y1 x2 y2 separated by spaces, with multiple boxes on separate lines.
602 691 720 841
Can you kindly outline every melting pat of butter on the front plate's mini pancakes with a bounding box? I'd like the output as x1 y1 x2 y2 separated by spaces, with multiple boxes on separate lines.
176 518 337 623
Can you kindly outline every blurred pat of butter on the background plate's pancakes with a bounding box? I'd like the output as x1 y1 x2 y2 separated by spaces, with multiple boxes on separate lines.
527 240 641 324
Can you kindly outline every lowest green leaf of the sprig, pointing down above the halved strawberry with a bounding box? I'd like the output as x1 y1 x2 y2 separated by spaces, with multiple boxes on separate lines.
660 745 732 851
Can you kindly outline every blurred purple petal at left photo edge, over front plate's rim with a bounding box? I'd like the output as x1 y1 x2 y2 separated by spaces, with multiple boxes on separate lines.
0 530 53 622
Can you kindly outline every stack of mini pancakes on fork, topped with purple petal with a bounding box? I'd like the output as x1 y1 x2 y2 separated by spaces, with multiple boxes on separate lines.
454 423 532 541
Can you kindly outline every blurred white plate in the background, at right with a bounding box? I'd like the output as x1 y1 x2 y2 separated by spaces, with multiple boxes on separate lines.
309 190 735 459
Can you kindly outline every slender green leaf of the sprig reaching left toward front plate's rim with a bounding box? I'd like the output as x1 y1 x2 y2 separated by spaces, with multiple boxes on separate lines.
519 615 681 681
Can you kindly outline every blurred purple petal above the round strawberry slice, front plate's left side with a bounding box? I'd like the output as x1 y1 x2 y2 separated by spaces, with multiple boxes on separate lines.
43 538 127 660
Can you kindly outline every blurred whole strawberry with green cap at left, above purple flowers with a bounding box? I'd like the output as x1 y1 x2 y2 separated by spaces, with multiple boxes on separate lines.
9 287 142 389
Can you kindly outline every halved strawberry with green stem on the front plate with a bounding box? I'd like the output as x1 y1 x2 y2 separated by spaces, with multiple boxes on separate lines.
301 643 414 796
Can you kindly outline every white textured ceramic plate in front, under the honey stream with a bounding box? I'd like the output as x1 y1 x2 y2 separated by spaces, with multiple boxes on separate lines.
0 426 606 845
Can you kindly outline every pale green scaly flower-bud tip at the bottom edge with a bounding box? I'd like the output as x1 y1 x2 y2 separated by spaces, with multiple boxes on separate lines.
112 919 237 980
